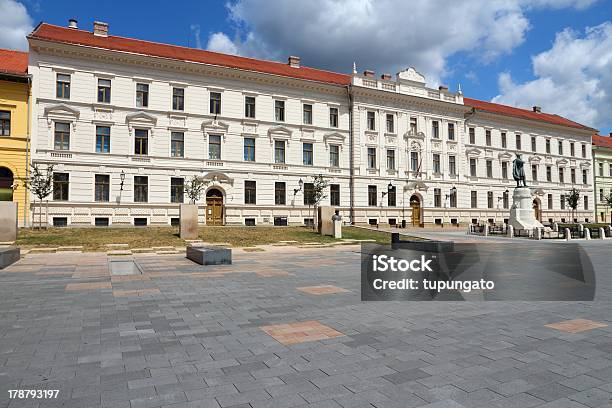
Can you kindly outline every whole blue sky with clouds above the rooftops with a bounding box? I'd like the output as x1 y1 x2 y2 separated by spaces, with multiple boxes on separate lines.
0 0 612 135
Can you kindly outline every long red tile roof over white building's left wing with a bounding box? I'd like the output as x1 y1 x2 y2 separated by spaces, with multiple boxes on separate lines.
30 23 351 85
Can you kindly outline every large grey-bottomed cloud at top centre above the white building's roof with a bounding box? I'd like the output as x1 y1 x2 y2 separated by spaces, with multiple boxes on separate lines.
208 0 593 85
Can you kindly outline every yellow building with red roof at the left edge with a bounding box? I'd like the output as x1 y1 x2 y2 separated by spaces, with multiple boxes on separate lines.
0 49 30 226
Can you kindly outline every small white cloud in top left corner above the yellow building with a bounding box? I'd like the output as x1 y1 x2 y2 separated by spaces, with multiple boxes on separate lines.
0 0 33 50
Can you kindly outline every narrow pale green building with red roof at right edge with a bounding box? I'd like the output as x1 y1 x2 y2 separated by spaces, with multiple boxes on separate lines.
593 134 612 223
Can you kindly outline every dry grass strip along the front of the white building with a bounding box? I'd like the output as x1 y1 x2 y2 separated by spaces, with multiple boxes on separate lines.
15 227 391 251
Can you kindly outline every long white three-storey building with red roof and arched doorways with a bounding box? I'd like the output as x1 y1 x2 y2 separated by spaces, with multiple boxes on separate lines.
28 23 593 225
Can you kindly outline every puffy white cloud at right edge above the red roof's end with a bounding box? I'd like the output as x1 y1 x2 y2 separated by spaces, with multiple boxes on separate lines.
493 22 612 127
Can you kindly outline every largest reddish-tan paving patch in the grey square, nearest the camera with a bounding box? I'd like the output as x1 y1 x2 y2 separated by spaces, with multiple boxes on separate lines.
260 320 344 346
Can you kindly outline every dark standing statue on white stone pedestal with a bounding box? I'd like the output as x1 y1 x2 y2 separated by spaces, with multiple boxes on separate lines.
508 153 544 231
